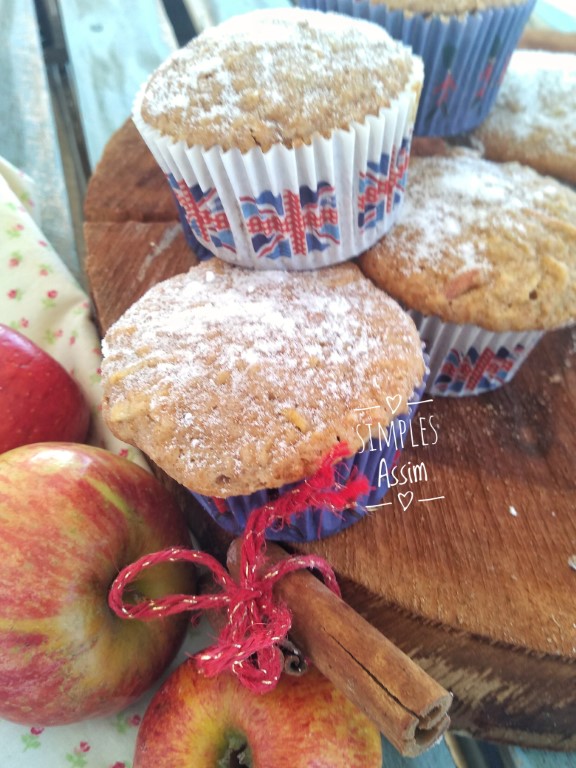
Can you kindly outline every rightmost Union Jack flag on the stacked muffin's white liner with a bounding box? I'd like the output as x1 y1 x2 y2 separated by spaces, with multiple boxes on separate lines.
358 137 410 230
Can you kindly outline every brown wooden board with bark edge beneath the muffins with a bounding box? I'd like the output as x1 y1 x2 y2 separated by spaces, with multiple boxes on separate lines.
85 122 576 750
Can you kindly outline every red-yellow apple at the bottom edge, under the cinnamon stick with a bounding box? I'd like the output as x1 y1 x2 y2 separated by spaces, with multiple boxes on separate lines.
134 659 382 768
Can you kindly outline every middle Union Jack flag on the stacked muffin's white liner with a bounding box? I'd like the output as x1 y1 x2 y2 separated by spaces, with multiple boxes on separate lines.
240 181 340 259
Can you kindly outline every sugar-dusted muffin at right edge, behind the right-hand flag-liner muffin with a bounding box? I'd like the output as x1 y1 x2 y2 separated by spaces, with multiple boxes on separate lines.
474 51 576 184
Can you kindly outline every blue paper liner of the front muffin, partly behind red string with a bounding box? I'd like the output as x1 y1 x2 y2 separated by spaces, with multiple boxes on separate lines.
191 379 426 542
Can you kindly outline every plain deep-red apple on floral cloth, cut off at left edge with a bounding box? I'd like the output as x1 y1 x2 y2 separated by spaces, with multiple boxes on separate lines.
0 324 90 453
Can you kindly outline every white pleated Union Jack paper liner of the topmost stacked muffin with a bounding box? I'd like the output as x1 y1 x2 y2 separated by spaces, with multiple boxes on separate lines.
133 59 423 269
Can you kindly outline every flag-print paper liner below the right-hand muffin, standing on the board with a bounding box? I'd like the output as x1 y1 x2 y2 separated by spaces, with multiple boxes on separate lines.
408 310 544 397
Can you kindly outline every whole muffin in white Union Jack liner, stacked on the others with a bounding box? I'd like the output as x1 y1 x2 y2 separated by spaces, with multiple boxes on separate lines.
133 8 424 269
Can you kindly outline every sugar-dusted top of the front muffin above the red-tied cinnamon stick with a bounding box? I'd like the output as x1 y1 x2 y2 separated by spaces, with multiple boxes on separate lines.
102 259 424 498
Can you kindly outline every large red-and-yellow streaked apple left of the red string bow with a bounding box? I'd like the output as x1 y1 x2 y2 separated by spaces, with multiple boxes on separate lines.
0 443 194 725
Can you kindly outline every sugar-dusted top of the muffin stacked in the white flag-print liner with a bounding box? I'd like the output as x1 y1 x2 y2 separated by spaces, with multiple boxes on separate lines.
134 8 423 152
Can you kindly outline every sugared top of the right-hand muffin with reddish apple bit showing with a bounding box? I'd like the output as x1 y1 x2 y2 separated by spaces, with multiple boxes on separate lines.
360 152 576 331
